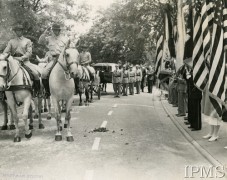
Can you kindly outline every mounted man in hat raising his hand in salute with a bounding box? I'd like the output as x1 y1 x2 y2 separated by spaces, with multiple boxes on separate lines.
38 24 70 96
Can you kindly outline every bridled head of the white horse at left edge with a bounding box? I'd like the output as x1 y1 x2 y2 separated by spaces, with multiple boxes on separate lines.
0 54 10 91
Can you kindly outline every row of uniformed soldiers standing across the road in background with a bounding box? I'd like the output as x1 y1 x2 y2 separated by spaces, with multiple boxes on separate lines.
112 64 154 98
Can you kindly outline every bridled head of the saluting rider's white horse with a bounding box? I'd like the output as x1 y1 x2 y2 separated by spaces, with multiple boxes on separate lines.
64 48 79 77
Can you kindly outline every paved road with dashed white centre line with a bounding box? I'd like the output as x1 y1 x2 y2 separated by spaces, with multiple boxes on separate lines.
0 85 210 180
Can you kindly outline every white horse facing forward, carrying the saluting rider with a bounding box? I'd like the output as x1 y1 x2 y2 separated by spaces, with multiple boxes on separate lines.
49 48 79 142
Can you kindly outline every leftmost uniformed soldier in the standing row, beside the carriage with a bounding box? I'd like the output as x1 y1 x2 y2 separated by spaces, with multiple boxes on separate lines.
112 64 123 98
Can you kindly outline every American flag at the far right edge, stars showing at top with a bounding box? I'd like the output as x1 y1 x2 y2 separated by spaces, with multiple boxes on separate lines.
208 0 226 116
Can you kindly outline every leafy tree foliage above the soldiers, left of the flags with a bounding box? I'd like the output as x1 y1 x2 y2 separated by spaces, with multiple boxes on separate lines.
82 0 171 64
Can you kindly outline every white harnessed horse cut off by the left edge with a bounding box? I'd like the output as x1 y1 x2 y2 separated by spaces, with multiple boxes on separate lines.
0 55 32 142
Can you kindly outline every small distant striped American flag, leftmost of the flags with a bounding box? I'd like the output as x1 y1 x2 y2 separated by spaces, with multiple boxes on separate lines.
155 32 164 74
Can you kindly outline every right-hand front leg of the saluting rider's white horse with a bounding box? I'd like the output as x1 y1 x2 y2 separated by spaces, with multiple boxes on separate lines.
65 97 74 142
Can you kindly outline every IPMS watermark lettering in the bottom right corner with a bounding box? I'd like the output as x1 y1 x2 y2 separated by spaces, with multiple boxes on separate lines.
184 165 227 179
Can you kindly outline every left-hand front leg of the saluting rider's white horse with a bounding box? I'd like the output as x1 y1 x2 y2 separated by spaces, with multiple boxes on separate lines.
52 97 62 141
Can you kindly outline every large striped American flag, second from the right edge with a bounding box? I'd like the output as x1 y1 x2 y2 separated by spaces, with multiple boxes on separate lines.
192 0 212 90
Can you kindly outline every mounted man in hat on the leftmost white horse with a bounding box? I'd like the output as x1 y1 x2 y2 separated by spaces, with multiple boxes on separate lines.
3 24 41 94
